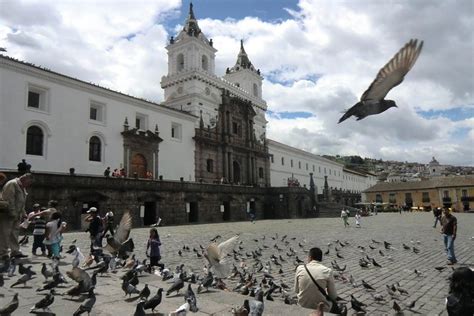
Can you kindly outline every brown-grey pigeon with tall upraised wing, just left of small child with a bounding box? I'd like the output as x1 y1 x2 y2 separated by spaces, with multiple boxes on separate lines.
105 211 135 256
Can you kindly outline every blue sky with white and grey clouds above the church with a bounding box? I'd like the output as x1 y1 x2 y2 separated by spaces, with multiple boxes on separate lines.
0 0 474 165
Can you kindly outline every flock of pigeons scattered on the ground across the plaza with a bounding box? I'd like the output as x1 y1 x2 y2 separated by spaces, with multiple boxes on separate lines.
0 212 446 316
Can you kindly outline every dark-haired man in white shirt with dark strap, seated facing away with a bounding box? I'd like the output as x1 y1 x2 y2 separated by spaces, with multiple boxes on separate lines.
295 247 347 315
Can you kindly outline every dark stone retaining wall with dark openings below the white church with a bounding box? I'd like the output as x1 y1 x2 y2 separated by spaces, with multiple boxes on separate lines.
1 172 317 230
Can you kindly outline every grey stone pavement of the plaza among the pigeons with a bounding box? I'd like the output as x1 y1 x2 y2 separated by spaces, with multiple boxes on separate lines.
0 213 474 315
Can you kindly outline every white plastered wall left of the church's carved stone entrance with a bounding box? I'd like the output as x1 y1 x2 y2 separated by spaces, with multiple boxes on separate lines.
0 57 196 180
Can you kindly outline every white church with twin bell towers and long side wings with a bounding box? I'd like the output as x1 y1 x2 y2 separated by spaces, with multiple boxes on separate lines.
0 3 375 193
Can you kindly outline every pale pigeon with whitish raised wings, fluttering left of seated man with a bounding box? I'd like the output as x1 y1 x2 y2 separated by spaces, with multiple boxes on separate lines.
204 235 239 279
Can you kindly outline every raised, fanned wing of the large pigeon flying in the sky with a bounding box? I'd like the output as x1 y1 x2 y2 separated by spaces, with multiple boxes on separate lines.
360 39 423 101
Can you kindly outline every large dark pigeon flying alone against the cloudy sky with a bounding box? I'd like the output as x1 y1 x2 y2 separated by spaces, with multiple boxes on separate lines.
338 39 423 123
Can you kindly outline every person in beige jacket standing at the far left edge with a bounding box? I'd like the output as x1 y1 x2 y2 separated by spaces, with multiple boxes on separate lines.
0 173 33 259
